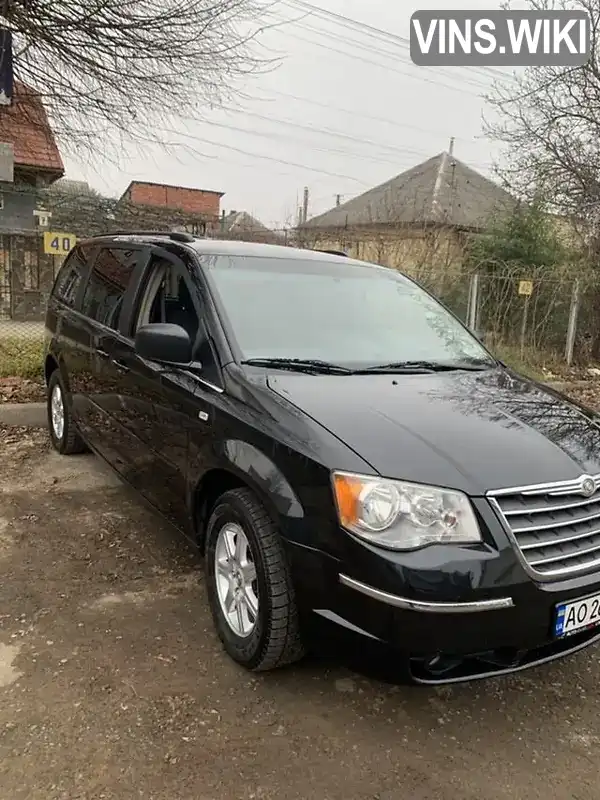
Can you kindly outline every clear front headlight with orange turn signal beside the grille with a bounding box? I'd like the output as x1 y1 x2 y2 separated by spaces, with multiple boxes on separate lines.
332 472 481 550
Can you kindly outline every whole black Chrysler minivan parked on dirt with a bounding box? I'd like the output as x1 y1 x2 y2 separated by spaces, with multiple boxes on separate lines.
45 233 600 683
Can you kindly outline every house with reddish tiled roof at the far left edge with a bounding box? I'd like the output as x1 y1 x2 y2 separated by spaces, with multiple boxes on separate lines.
0 82 64 320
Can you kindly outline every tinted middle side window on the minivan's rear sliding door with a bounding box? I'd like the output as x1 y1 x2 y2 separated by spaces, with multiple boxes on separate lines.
81 247 141 330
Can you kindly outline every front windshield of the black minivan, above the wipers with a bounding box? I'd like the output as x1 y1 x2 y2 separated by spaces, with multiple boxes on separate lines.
208 256 494 368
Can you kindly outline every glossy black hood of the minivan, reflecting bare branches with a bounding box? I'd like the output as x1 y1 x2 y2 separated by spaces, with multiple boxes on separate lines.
267 369 600 495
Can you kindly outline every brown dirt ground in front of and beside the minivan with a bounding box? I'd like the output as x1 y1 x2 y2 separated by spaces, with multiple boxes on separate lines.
0 428 600 800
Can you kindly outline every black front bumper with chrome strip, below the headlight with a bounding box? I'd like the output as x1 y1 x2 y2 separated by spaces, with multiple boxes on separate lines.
288 520 600 684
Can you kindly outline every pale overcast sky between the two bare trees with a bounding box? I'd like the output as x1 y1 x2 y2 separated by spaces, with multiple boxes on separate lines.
66 0 522 227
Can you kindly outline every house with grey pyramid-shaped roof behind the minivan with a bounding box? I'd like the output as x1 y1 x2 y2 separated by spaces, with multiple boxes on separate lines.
298 151 516 273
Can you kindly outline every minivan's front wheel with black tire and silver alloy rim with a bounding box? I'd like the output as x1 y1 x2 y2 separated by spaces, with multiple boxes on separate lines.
205 489 305 672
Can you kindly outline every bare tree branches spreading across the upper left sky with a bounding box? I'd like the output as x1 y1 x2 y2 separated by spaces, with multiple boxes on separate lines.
0 0 274 156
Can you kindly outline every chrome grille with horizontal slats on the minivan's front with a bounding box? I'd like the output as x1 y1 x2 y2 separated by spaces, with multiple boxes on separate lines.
488 475 600 578
